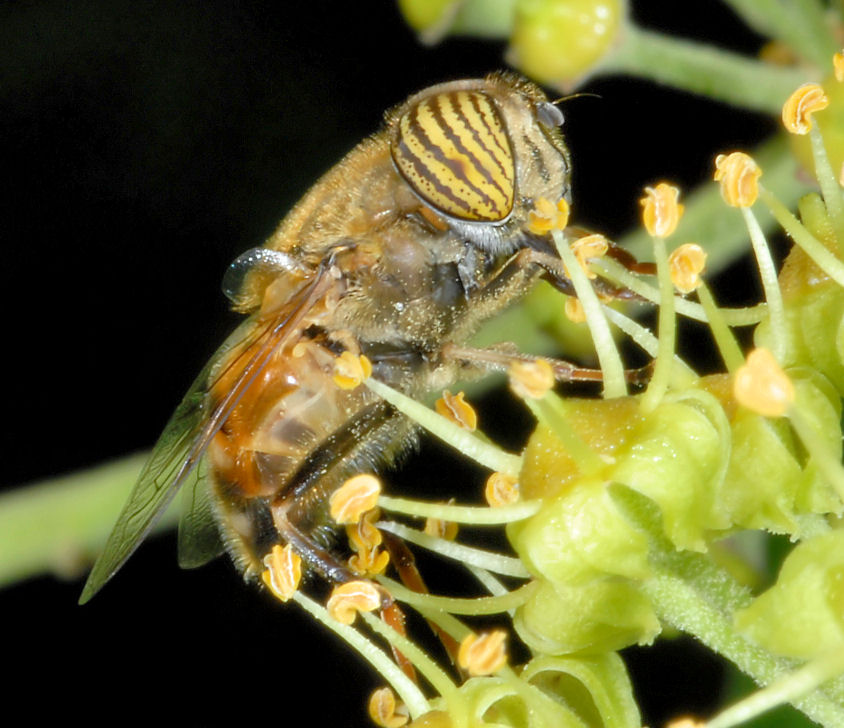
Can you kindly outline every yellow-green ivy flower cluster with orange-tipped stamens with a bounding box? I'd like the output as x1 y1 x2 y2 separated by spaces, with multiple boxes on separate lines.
254 48 844 728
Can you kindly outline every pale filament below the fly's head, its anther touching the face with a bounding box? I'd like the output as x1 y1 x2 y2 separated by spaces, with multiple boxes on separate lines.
552 230 627 398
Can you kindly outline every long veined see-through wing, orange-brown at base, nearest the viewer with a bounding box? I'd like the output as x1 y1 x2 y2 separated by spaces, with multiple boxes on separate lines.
79 261 336 604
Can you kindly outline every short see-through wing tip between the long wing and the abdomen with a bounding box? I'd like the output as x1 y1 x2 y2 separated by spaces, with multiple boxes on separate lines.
179 463 223 569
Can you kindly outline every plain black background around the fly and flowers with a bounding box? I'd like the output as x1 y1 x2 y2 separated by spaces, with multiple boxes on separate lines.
0 0 773 725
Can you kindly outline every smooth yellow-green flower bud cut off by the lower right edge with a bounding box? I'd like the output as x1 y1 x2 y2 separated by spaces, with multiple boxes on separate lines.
735 530 844 659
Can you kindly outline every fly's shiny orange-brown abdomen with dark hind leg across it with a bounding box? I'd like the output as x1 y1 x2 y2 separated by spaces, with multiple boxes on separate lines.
208 341 400 572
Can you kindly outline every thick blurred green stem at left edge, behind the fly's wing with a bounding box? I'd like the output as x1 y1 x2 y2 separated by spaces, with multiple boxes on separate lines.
0 454 157 586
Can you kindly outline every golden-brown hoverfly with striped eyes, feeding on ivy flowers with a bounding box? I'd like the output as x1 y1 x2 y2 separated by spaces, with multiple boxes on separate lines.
80 74 648 602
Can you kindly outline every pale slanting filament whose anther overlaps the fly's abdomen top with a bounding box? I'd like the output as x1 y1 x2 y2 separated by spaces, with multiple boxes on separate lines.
365 377 522 476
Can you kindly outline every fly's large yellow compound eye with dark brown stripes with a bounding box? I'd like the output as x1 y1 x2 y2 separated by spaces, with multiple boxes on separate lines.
391 91 516 222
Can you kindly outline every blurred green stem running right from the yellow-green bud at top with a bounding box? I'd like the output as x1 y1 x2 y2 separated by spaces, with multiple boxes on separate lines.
595 25 812 114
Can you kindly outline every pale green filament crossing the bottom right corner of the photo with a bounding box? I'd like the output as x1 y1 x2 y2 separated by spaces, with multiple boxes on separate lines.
706 645 844 728
